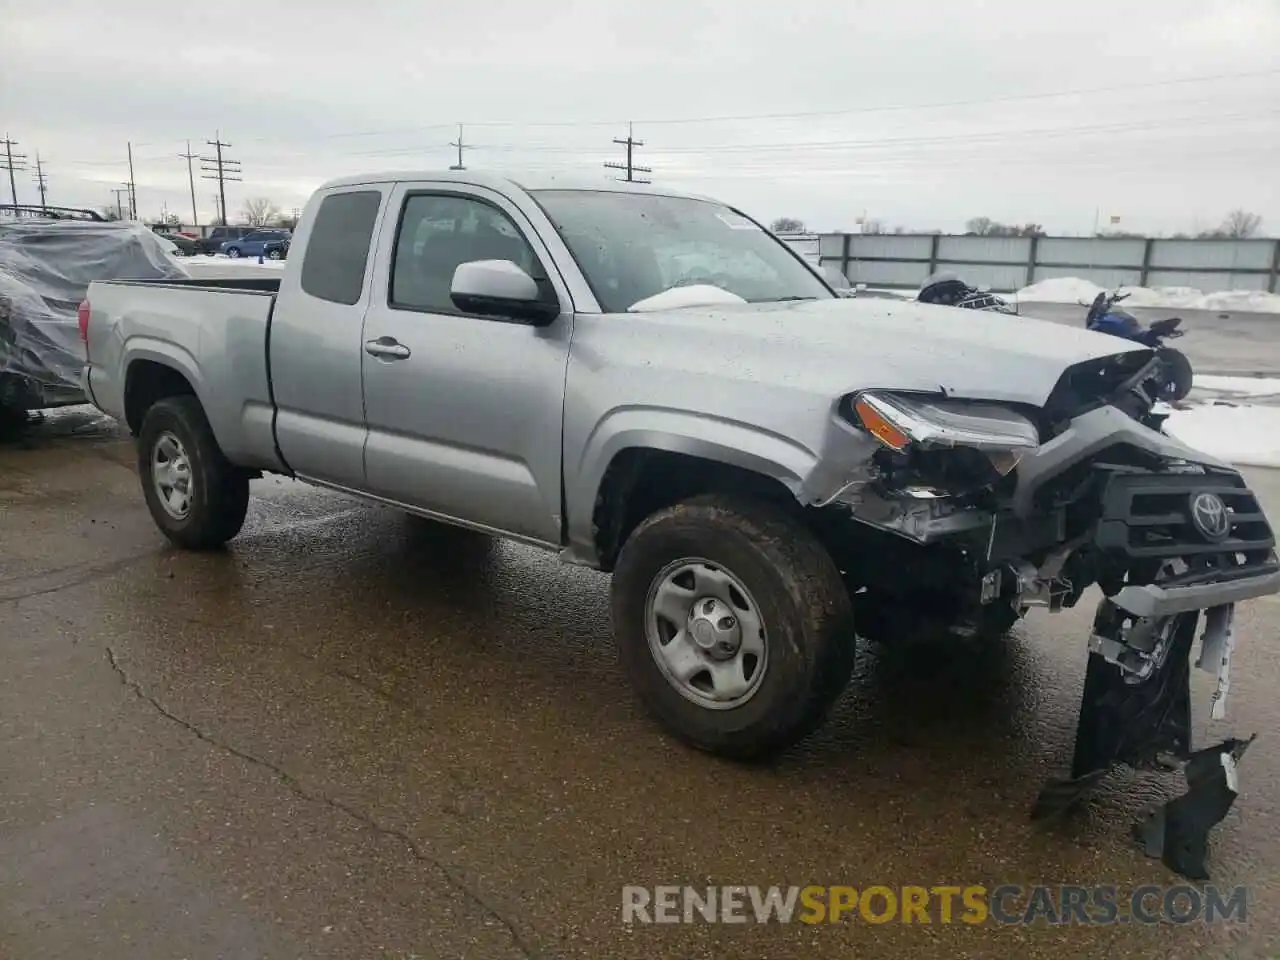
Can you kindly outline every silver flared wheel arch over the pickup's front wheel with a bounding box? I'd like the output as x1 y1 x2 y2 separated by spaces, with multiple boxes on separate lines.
566 406 818 559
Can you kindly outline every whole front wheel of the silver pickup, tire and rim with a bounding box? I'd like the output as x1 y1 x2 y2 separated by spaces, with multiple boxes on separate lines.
612 497 855 759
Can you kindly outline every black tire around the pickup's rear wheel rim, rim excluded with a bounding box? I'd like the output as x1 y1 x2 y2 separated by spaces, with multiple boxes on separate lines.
138 396 248 550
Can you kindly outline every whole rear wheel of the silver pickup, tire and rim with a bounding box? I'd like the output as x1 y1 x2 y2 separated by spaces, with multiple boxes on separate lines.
138 396 248 550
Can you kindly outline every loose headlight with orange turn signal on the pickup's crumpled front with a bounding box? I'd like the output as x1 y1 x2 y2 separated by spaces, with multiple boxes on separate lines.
852 390 1039 476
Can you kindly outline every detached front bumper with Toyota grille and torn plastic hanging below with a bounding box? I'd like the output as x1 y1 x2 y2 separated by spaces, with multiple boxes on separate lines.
1033 471 1280 879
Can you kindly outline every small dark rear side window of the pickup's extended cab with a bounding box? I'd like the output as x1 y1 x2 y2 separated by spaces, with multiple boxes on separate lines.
302 189 383 305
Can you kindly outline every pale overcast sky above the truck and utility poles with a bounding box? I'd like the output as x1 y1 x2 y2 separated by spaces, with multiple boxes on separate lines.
0 0 1280 233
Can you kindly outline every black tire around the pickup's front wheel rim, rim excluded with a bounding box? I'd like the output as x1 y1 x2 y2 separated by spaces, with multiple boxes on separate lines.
612 495 856 760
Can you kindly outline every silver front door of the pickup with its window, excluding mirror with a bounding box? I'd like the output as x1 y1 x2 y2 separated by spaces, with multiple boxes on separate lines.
362 182 573 544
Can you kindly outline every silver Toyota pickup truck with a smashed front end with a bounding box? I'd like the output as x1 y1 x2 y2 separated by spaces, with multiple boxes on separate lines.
82 172 1280 873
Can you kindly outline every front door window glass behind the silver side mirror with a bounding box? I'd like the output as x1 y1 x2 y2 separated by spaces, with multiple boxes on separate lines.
390 195 543 314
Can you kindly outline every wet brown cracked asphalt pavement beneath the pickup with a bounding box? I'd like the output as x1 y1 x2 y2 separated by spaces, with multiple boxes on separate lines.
0 408 1280 960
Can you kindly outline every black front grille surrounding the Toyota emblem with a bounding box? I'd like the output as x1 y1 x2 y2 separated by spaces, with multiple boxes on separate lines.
1094 471 1275 568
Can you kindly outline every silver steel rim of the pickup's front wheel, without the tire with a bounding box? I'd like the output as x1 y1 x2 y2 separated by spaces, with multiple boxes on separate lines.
645 557 769 710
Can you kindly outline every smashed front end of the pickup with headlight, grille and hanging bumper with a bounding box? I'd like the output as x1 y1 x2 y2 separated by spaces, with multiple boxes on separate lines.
803 351 1280 879
